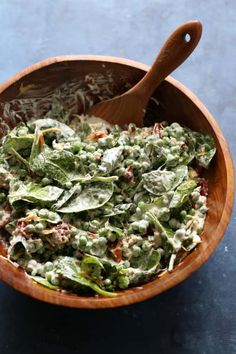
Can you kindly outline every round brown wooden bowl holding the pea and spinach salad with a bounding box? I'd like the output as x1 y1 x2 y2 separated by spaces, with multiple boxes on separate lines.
0 56 234 308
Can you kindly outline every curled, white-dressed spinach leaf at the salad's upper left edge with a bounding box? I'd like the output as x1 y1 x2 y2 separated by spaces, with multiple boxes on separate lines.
28 118 75 137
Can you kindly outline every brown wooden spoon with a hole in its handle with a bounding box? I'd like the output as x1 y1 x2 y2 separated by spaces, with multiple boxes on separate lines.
86 20 202 126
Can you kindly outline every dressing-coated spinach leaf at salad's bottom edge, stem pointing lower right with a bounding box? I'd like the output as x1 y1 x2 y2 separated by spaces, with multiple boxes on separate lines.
55 257 117 297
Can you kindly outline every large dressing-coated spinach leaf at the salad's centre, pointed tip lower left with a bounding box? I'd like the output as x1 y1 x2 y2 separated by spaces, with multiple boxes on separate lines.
57 183 113 213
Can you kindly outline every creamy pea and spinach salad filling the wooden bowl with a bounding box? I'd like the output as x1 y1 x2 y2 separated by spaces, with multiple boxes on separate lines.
0 115 216 297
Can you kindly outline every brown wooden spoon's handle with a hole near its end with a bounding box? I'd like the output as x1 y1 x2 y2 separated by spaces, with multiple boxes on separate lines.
131 20 202 101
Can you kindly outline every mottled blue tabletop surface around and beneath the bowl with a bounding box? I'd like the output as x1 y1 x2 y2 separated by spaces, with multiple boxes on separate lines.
0 0 236 354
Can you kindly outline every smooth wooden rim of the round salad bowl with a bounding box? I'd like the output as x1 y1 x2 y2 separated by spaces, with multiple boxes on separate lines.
0 55 234 309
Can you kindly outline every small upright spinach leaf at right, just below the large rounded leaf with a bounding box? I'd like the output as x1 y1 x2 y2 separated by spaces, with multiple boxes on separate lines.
169 179 197 208
